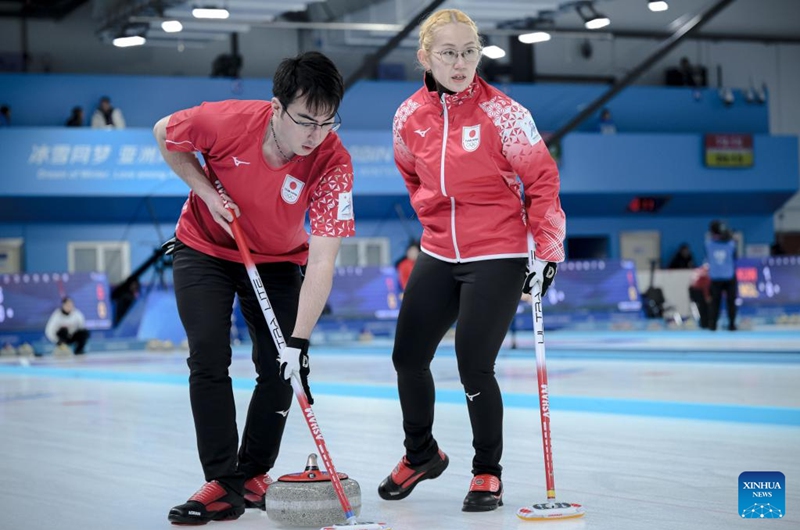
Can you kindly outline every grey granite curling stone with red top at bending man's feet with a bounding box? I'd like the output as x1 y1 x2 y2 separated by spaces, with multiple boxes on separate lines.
264 453 361 528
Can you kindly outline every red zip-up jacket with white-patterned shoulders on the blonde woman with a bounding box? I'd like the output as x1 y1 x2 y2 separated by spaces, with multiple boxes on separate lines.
393 75 566 263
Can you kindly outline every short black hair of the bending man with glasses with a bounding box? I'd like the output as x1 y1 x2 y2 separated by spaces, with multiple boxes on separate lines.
272 52 344 116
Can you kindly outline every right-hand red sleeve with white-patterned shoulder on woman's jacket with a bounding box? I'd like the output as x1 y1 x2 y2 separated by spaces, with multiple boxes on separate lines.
484 98 566 262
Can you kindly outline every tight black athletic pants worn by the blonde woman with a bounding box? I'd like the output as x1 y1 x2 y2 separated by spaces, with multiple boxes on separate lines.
392 252 526 477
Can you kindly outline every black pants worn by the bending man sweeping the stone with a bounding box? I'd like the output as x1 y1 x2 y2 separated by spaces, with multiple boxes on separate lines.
173 242 302 491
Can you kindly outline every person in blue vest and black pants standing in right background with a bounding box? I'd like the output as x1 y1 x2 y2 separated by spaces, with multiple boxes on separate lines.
706 221 737 331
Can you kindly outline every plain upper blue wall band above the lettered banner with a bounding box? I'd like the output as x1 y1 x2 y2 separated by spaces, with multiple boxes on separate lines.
0 74 769 133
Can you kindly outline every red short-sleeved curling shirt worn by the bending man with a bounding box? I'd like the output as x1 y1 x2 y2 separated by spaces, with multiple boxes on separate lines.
167 100 355 265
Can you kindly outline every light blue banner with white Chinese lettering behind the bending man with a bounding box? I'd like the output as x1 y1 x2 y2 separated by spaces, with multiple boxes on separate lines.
0 127 406 197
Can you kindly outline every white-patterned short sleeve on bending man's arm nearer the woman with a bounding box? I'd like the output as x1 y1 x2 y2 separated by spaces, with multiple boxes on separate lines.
308 164 356 237
